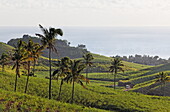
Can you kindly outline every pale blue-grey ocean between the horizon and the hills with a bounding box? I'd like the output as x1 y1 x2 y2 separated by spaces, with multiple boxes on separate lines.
0 27 170 59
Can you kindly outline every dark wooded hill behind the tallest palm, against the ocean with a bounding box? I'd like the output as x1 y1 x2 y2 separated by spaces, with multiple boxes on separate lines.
7 35 88 59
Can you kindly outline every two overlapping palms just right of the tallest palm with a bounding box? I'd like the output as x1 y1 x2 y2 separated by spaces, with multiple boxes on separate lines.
52 57 89 103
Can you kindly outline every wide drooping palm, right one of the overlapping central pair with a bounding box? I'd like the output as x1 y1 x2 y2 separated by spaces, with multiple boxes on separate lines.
64 60 89 103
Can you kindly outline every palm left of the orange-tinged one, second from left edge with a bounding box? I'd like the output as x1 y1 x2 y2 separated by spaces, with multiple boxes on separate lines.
12 40 27 92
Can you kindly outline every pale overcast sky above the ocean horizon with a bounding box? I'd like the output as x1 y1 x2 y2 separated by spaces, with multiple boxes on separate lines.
0 0 170 26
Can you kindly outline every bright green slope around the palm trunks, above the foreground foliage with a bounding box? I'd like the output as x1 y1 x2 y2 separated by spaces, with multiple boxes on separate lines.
0 67 170 112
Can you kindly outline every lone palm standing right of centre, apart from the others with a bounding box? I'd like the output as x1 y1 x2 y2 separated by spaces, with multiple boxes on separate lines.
109 58 124 89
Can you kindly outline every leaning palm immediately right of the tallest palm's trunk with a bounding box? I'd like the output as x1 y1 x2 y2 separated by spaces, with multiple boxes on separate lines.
53 57 70 100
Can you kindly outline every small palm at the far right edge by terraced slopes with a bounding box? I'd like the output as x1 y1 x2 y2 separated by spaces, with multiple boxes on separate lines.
156 72 170 96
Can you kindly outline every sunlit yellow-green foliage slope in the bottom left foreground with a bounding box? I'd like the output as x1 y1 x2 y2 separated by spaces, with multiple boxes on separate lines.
0 89 107 112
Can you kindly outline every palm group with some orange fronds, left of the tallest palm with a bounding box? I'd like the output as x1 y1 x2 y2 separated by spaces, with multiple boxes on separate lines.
10 40 44 93
